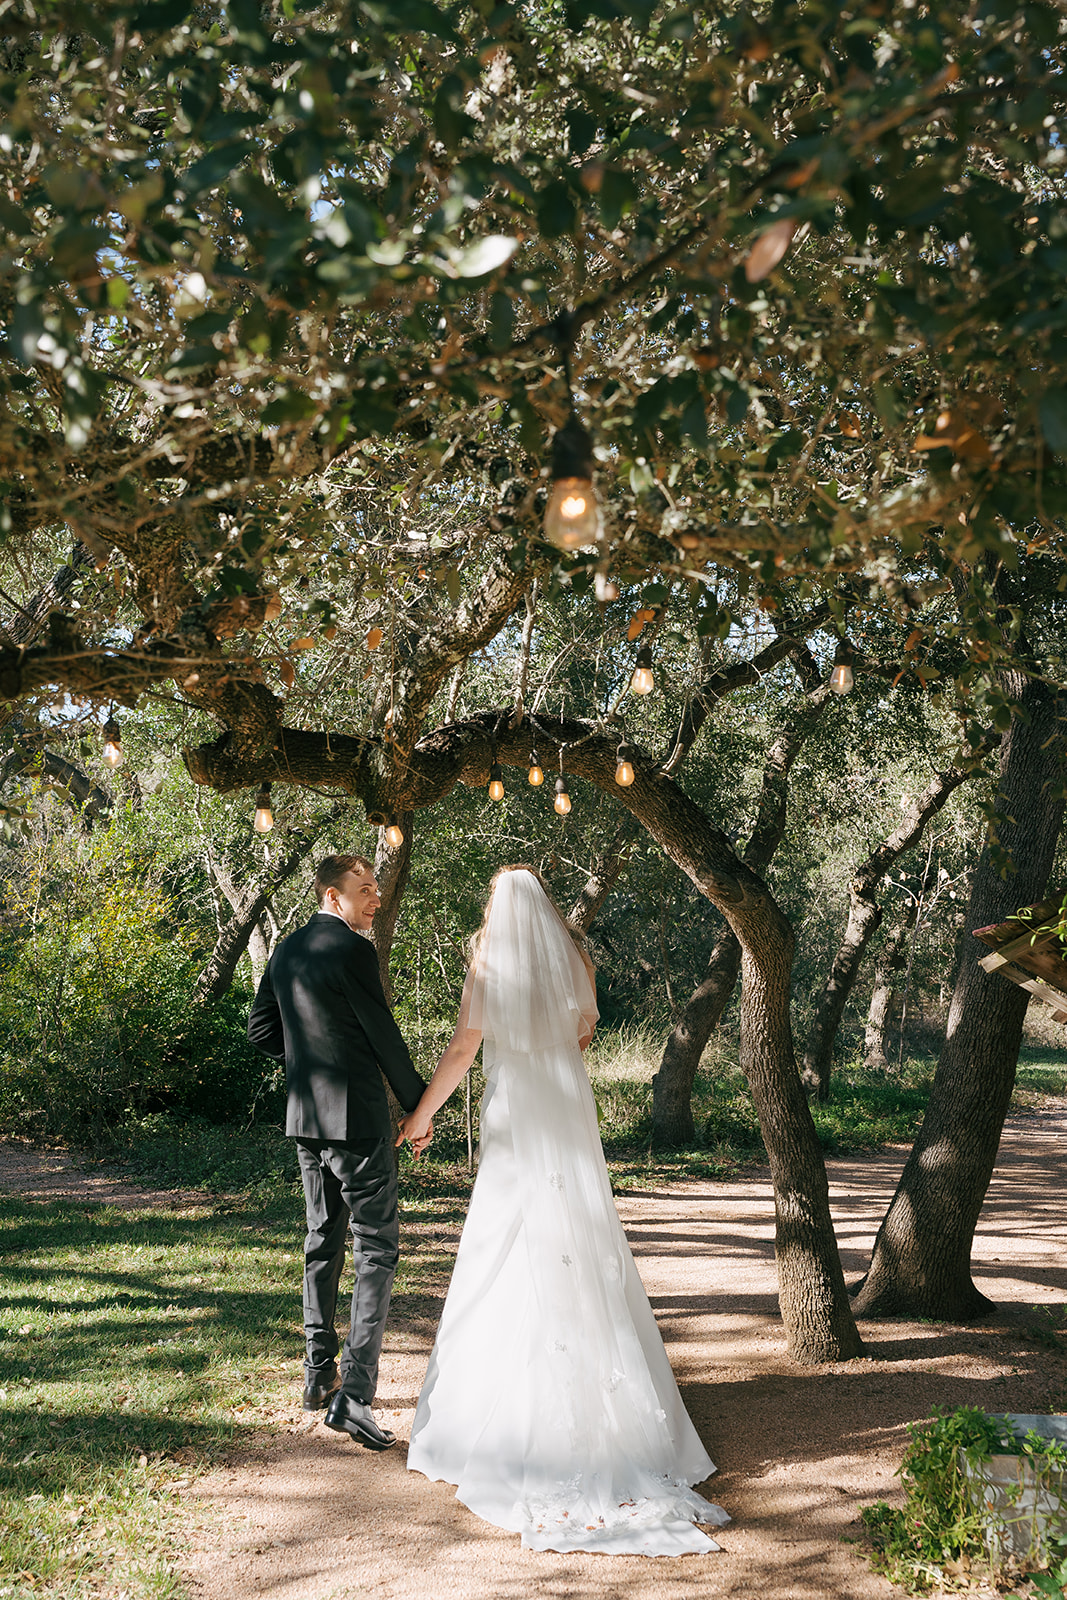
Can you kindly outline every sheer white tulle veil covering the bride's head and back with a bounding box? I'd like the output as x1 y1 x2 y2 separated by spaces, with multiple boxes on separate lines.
467 867 595 1054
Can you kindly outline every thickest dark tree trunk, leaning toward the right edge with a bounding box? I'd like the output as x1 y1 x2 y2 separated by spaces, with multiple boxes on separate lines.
856 672 1064 1320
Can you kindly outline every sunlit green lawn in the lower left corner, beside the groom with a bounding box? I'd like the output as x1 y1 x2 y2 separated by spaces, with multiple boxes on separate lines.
0 1198 302 1600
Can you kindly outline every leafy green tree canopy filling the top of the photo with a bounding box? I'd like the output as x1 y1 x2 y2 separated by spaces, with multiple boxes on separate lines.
0 0 1067 816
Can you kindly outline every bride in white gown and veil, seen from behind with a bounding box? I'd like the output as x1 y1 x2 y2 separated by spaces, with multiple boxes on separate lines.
397 867 729 1555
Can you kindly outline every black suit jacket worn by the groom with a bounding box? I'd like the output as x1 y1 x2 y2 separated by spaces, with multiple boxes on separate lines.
248 912 426 1144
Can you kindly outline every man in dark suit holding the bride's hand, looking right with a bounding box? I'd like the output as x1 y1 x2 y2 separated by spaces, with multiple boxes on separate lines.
248 856 429 1450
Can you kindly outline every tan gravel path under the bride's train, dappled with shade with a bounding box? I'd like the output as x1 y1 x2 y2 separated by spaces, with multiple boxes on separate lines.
0 1109 1067 1600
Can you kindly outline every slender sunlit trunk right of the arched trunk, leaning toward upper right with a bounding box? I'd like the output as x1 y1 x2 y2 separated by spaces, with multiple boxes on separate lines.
801 766 976 1101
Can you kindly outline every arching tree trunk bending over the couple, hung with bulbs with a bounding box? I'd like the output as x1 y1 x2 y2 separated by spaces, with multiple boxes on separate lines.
187 707 859 1362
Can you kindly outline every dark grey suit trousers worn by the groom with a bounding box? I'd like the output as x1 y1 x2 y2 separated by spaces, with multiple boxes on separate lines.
296 1139 400 1405
